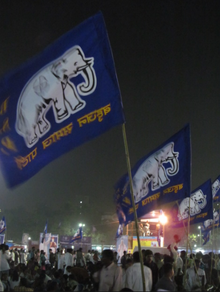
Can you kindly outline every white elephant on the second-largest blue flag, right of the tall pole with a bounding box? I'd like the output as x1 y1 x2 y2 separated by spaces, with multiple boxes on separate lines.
133 142 179 202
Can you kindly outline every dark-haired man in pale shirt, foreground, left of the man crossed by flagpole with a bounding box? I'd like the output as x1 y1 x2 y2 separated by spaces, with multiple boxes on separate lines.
99 249 122 291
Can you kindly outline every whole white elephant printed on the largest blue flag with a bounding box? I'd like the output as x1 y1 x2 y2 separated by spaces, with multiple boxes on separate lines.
15 46 96 148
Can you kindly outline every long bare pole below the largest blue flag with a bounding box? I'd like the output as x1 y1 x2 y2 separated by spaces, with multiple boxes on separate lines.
122 124 146 291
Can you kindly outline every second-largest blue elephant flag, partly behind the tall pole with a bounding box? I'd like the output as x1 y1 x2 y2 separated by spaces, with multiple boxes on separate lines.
115 125 191 225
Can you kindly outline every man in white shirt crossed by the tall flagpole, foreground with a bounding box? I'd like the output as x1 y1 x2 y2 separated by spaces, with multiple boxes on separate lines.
125 251 153 291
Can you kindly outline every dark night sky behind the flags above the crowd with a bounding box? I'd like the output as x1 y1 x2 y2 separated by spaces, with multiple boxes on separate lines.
0 0 220 244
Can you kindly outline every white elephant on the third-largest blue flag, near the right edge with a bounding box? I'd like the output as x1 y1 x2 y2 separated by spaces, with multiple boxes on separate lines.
177 190 207 221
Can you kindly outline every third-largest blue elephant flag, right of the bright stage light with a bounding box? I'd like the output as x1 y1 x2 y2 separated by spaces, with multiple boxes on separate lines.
170 179 213 228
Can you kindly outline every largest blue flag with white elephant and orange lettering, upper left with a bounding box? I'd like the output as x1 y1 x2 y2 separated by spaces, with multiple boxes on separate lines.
0 13 124 187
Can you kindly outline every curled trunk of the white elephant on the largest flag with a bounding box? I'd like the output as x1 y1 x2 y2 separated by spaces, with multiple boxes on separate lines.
78 64 96 95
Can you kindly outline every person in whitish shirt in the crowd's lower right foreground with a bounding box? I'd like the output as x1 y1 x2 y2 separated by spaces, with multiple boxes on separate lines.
185 259 206 291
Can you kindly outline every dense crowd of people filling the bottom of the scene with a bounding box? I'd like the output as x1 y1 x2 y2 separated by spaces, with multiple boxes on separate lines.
0 239 220 291
